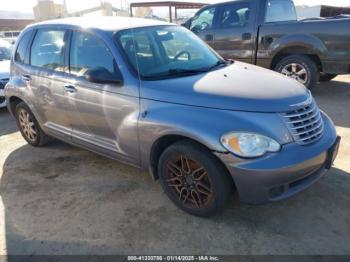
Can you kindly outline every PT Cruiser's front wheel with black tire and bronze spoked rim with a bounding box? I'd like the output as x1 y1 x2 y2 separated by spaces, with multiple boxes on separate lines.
158 141 234 217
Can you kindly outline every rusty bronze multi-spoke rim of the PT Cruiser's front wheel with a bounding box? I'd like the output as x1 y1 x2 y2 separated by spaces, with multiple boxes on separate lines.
166 155 213 208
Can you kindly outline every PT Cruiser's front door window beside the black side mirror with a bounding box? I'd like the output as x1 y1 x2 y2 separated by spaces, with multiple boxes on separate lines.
70 32 115 75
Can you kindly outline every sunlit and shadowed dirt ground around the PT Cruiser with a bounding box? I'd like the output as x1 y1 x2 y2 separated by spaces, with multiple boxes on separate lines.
0 76 350 254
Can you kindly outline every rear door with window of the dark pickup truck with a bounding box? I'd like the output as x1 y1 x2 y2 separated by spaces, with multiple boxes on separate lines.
211 1 257 63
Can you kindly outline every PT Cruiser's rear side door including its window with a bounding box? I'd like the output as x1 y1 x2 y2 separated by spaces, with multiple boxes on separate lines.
27 28 71 139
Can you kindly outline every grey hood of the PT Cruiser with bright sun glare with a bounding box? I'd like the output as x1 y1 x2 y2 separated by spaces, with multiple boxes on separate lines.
141 62 309 112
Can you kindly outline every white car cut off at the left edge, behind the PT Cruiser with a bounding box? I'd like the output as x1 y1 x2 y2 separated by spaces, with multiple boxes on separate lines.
0 39 12 108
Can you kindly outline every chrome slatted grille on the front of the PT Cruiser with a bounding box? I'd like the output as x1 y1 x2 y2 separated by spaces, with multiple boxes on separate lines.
282 101 323 145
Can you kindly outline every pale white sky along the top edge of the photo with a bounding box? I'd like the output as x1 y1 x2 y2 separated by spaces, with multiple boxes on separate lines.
0 0 350 13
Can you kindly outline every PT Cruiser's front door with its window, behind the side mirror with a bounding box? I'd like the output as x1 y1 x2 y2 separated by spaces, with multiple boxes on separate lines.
65 30 139 165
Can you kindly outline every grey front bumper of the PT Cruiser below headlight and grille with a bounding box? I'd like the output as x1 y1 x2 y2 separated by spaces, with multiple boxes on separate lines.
217 115 337 204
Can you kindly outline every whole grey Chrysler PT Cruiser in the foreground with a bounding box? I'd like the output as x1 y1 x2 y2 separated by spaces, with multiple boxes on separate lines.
5 17 339 216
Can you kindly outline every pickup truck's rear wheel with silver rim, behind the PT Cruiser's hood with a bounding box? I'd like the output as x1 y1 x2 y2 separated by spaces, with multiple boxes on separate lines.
275 55 319 88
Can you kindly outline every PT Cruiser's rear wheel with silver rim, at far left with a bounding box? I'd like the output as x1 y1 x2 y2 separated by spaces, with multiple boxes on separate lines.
15 102 52 147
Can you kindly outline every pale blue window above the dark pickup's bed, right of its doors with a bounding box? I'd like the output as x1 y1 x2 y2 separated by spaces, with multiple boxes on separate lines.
265 0 297 23
